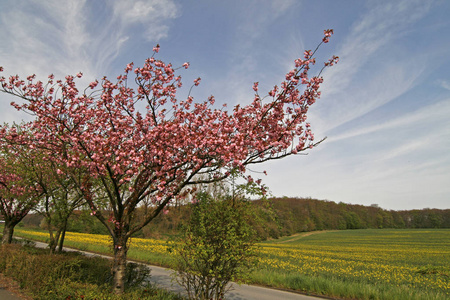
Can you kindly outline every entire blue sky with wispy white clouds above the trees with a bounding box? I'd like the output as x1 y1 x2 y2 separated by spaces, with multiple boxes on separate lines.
0 0 450 210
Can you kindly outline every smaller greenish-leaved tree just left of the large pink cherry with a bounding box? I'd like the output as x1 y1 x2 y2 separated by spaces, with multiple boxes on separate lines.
0 124 85 253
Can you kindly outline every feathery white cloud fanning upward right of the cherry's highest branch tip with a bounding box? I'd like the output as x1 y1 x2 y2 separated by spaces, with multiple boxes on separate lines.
314 1 431 131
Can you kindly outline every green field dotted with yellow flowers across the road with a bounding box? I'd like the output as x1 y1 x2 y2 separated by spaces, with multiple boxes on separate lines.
4 228 450 300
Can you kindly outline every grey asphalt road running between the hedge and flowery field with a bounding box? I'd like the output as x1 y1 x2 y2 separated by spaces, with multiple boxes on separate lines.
23 242 330 300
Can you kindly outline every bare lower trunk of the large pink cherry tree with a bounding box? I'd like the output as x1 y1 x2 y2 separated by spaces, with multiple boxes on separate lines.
112 237 128 294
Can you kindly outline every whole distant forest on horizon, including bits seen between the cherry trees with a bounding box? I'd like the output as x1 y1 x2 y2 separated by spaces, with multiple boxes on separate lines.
22 197 450 240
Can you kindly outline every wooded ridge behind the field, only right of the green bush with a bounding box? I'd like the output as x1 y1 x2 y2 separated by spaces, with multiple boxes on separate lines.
254 197 450 238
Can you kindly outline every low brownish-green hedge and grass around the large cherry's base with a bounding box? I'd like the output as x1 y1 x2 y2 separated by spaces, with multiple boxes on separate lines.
0 244 182 300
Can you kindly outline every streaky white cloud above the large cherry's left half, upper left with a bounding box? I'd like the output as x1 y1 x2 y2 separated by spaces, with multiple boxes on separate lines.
0 0 179 122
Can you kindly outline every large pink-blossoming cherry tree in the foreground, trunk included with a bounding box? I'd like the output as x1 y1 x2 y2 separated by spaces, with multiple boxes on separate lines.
0 30 338 293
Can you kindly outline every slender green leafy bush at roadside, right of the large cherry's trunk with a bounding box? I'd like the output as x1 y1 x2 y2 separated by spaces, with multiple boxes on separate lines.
175 193 256 300
